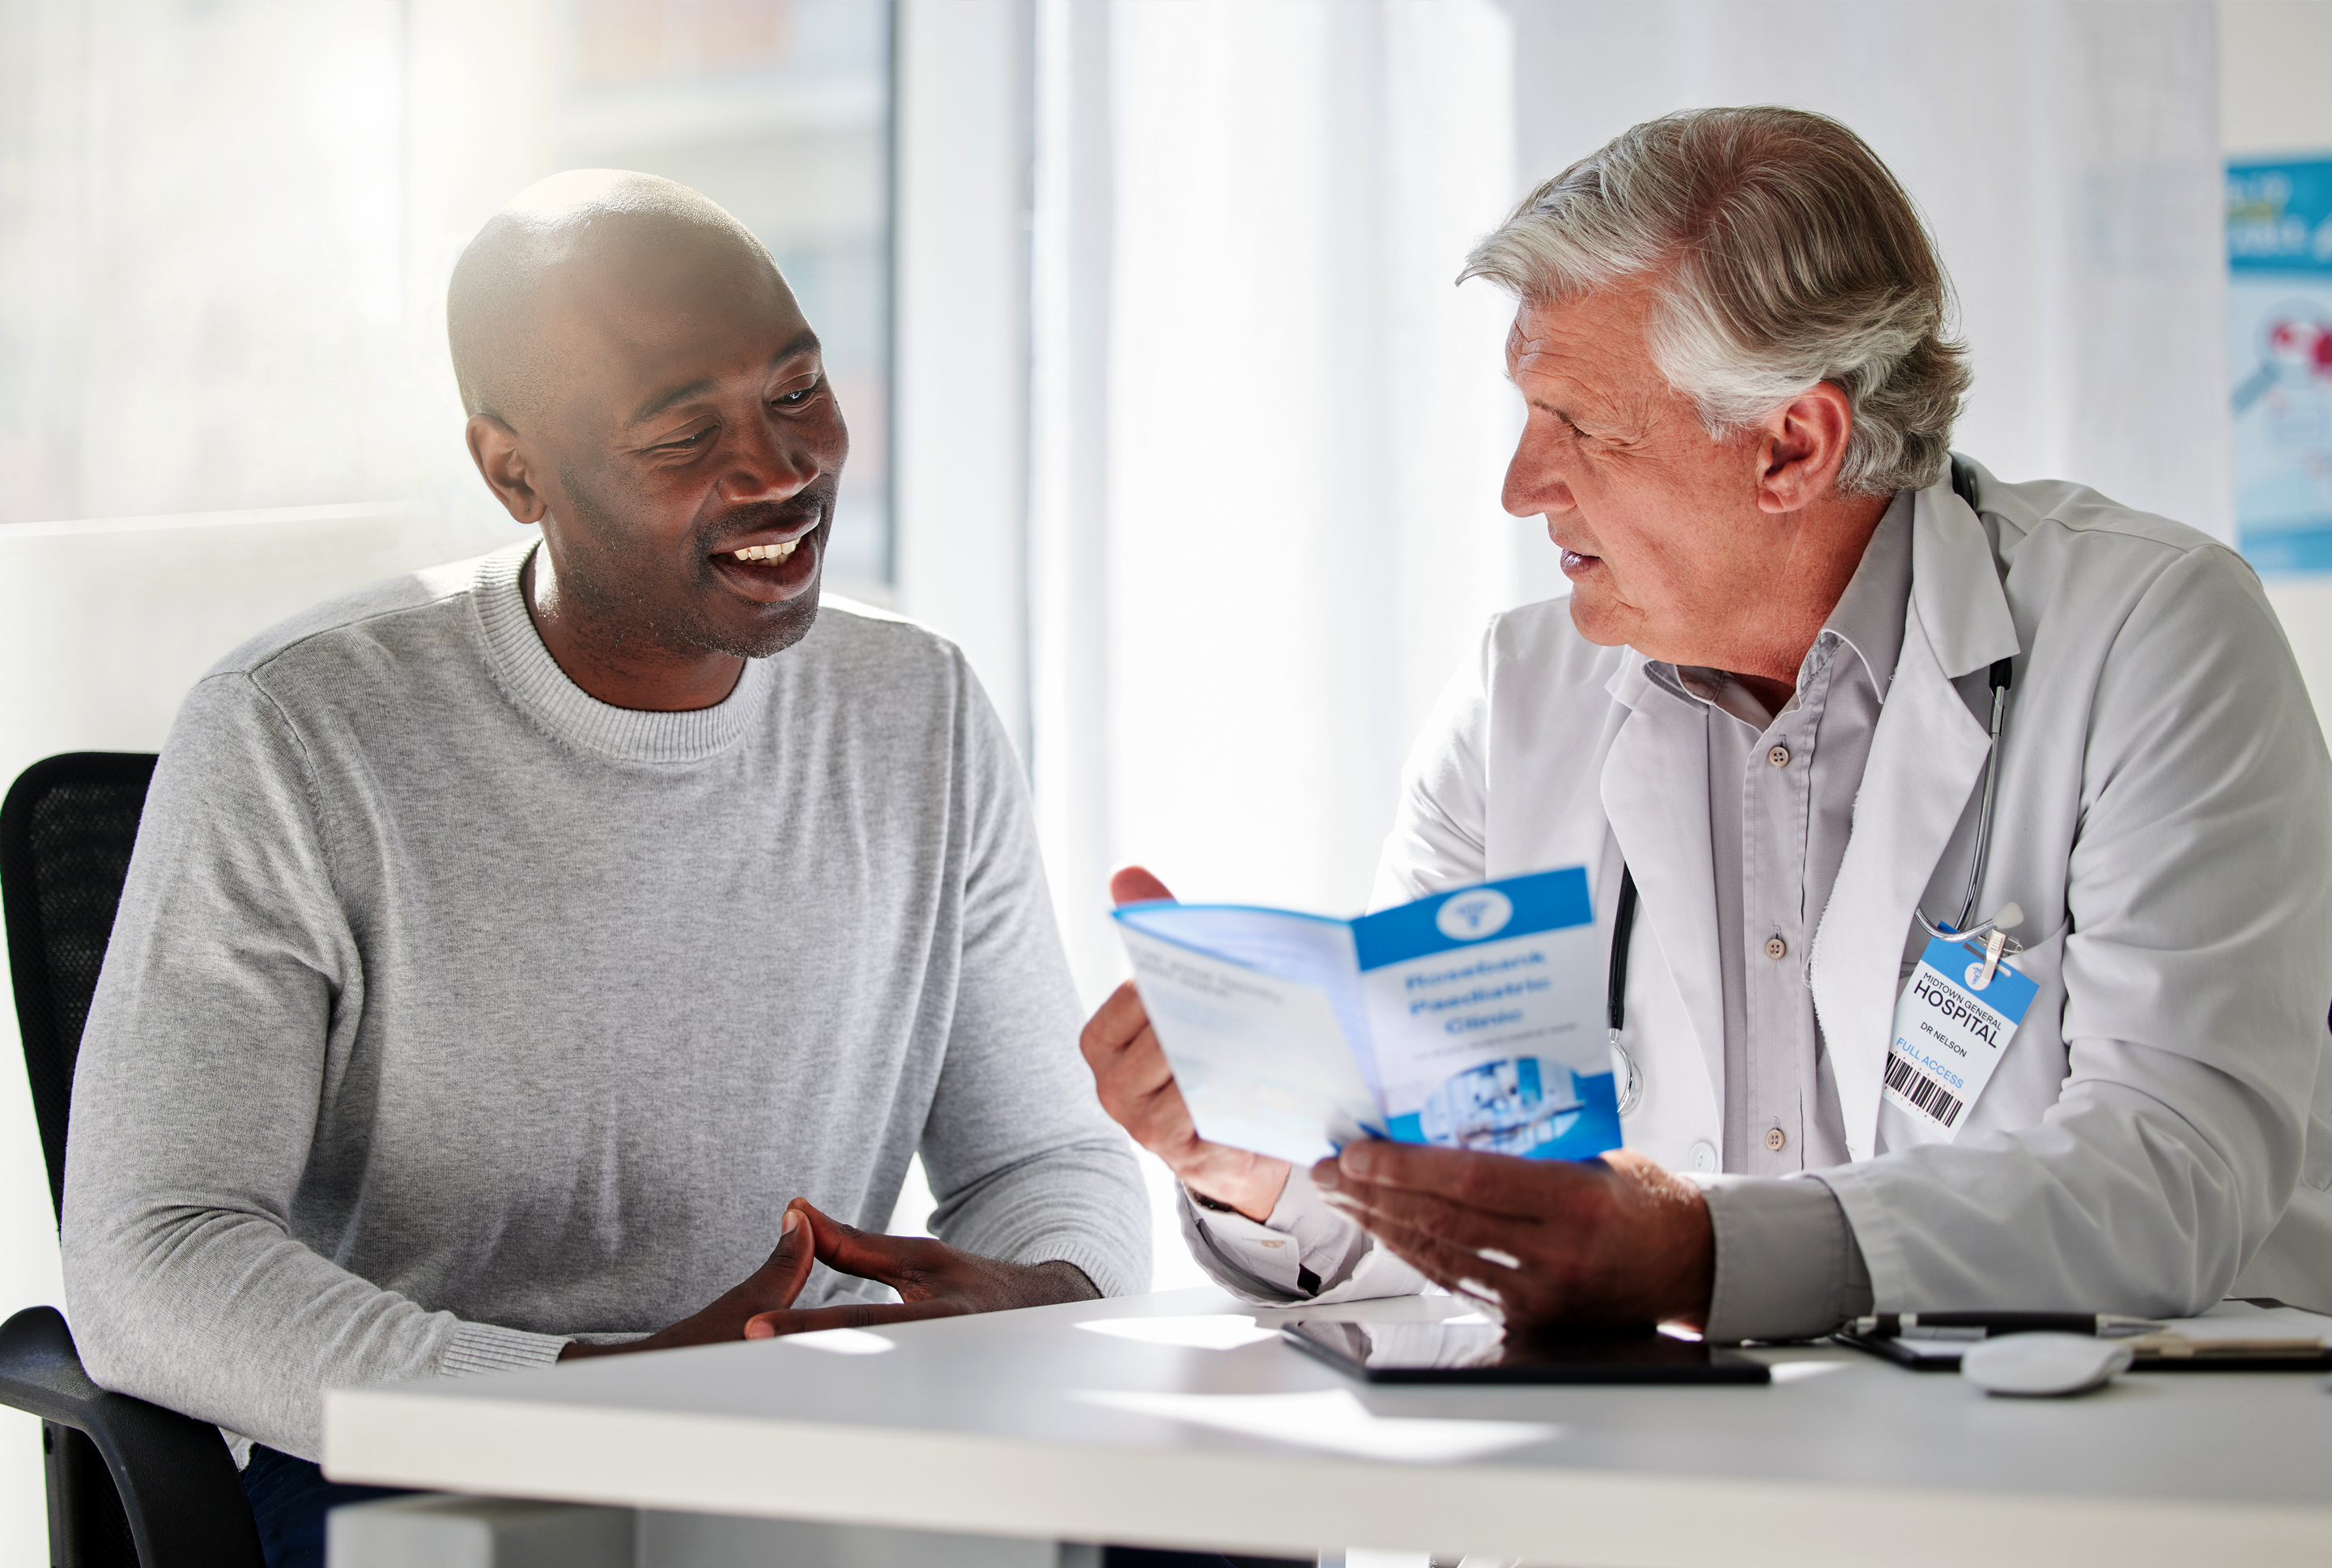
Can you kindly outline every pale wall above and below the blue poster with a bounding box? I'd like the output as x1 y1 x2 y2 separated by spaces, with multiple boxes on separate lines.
2218 0 2332 729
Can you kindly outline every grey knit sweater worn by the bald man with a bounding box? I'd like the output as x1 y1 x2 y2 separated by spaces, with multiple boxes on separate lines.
63 547 1150 1456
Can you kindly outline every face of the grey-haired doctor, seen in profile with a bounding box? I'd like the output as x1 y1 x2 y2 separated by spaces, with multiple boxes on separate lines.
1504 278 1786 669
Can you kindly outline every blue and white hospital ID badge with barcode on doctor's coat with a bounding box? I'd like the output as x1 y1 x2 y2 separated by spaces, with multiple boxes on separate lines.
1887 939 2040 1144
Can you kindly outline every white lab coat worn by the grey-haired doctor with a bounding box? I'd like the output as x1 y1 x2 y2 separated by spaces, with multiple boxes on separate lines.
1369 458 2332 1314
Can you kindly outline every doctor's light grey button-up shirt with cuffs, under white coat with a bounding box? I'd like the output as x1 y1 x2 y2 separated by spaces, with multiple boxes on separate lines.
1182 489 1913 1340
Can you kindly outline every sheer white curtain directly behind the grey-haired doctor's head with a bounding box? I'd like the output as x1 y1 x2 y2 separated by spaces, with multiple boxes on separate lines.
1511 0 2234 538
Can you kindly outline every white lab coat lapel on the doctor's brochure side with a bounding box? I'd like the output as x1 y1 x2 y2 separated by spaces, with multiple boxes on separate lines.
1602 655 1726 1104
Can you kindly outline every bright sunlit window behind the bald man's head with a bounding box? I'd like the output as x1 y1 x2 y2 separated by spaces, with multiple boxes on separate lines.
0 0 893 601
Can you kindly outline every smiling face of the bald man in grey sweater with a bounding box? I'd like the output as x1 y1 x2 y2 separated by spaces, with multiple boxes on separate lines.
525 219 849 660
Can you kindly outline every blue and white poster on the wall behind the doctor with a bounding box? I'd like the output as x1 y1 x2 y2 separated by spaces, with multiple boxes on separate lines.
2227 156 2332 576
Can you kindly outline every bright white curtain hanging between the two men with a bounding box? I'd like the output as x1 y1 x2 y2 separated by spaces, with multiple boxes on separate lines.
1031 0 1520 992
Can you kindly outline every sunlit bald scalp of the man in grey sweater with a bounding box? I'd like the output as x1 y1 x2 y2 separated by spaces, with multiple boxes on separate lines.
445 168 798 429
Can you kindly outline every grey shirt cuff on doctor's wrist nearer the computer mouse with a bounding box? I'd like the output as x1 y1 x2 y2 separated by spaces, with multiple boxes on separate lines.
1700 1176 1870 1345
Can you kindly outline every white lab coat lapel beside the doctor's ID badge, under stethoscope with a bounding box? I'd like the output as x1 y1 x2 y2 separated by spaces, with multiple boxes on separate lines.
1800 458 2017 1160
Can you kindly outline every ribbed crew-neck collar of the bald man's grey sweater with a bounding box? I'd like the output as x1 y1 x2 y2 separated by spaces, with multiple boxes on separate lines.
469 541 769 762
